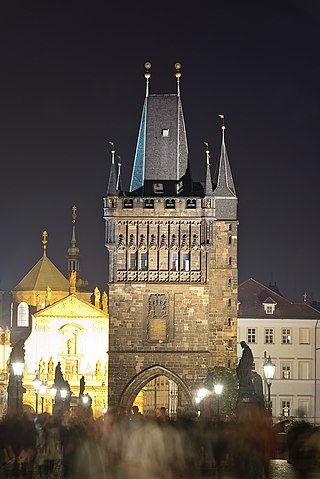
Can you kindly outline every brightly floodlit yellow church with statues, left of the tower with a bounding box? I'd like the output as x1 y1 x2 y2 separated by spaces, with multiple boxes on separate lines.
0 212 109 417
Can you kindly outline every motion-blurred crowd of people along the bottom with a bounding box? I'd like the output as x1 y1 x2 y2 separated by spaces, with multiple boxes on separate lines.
0 406 318 479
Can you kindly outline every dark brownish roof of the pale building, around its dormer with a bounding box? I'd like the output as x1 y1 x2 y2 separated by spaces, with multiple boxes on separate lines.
238 278 320 320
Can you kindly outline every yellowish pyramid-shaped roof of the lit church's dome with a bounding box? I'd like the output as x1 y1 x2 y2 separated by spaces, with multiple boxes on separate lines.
13 255 69 292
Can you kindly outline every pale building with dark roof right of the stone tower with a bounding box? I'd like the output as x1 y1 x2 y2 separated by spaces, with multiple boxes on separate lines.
238 278 320 423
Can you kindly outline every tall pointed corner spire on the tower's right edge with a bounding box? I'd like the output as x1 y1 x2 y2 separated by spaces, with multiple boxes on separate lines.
213 115 236 197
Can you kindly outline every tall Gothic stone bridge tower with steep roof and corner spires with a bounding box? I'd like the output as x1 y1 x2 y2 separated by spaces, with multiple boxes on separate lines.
104 64 238 409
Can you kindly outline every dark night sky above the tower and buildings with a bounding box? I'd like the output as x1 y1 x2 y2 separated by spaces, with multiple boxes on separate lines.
0 0 320 301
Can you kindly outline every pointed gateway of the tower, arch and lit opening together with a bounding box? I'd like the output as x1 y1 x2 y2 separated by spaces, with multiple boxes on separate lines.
120 365 194 417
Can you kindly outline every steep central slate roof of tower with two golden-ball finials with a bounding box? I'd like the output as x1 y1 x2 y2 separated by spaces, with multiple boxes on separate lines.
130 63 191 194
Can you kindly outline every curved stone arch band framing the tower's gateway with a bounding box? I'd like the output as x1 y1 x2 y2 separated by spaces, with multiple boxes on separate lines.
120 364 194 412
